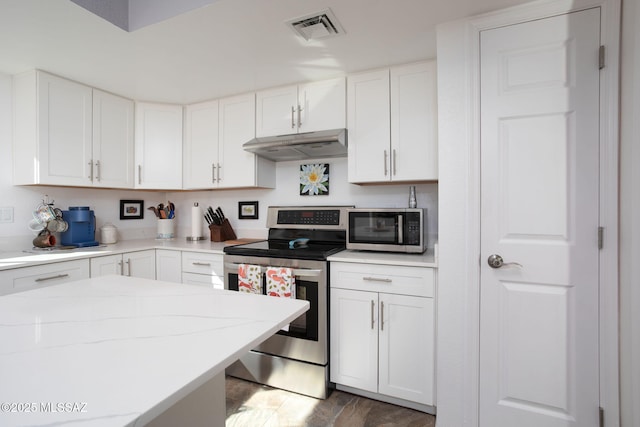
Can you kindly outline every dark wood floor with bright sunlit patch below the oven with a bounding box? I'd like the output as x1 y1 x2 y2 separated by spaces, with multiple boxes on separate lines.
226 377 436 427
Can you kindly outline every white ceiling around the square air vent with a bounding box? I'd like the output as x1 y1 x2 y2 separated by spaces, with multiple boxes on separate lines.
0 0 528 104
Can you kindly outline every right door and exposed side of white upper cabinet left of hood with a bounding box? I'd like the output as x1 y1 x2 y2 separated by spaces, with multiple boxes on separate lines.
216 93 276 188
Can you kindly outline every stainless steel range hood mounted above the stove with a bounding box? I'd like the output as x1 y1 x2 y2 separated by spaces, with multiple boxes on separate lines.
242 129 347 162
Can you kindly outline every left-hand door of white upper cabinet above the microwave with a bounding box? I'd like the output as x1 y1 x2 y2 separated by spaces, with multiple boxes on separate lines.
347 69 391 183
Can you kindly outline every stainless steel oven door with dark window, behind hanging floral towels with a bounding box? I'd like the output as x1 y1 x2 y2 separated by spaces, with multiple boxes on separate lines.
224 254 328 365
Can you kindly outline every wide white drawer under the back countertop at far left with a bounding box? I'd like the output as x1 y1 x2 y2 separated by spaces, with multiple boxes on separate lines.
0 259 89 295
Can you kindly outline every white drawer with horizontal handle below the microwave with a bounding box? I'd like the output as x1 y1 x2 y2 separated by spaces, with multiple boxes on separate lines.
330 262 435 297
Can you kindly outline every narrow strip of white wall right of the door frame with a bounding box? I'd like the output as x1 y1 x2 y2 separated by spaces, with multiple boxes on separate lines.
620 1 640 427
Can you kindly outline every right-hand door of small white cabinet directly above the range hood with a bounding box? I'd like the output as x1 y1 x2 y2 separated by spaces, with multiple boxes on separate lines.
298 77 347 132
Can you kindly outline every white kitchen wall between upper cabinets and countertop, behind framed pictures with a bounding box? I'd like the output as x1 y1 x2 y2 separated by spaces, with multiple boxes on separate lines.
0 74 438 251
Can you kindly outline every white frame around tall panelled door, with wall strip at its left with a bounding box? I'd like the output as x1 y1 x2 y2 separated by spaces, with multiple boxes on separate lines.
437 0 621 427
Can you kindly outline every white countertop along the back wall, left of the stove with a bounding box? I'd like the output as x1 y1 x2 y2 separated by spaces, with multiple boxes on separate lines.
0 238 256 271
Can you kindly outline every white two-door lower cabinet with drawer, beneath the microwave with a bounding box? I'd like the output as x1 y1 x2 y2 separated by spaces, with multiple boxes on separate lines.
330 262 435 406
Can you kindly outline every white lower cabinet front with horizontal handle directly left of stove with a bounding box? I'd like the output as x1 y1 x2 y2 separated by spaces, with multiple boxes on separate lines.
182 252 224 289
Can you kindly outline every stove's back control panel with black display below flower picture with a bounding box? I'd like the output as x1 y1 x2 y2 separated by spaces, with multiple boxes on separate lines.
267 206 349 229
